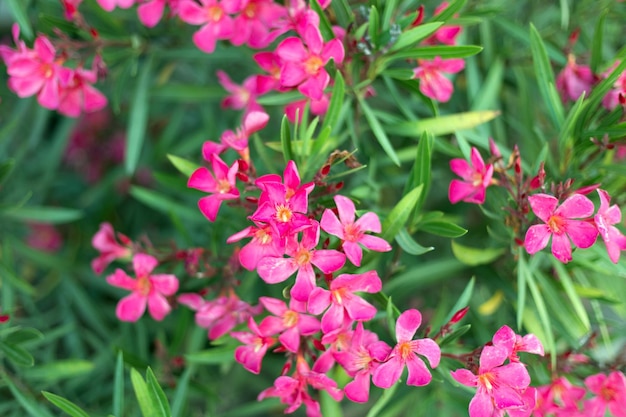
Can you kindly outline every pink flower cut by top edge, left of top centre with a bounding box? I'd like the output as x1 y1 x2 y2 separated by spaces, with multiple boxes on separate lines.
178 0 240 54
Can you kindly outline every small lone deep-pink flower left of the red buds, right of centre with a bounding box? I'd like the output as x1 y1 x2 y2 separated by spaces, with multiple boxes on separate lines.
448 148 493 204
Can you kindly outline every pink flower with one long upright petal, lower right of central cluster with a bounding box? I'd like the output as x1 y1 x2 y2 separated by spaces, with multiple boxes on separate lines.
372 309 441 388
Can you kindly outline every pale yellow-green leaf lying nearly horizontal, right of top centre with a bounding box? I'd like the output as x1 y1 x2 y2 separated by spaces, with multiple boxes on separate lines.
385 110 500 138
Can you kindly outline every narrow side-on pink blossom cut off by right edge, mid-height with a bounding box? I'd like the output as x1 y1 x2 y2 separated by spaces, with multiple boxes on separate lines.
593 189 626 263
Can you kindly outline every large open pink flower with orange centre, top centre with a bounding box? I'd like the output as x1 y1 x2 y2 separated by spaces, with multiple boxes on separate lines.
276 25 345 100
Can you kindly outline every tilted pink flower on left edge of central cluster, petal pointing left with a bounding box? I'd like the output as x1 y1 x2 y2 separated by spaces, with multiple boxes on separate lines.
226 223 285 271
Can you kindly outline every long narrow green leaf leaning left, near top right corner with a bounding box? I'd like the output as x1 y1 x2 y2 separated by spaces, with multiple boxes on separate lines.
530 23 563 129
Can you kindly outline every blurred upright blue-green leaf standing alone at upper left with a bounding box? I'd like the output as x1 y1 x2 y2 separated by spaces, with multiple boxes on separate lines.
124 57 152 175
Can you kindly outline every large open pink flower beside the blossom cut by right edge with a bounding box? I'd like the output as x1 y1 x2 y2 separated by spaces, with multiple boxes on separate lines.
524 194 598 263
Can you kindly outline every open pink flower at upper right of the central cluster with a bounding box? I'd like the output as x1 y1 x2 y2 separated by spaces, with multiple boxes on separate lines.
320 195 391 266
